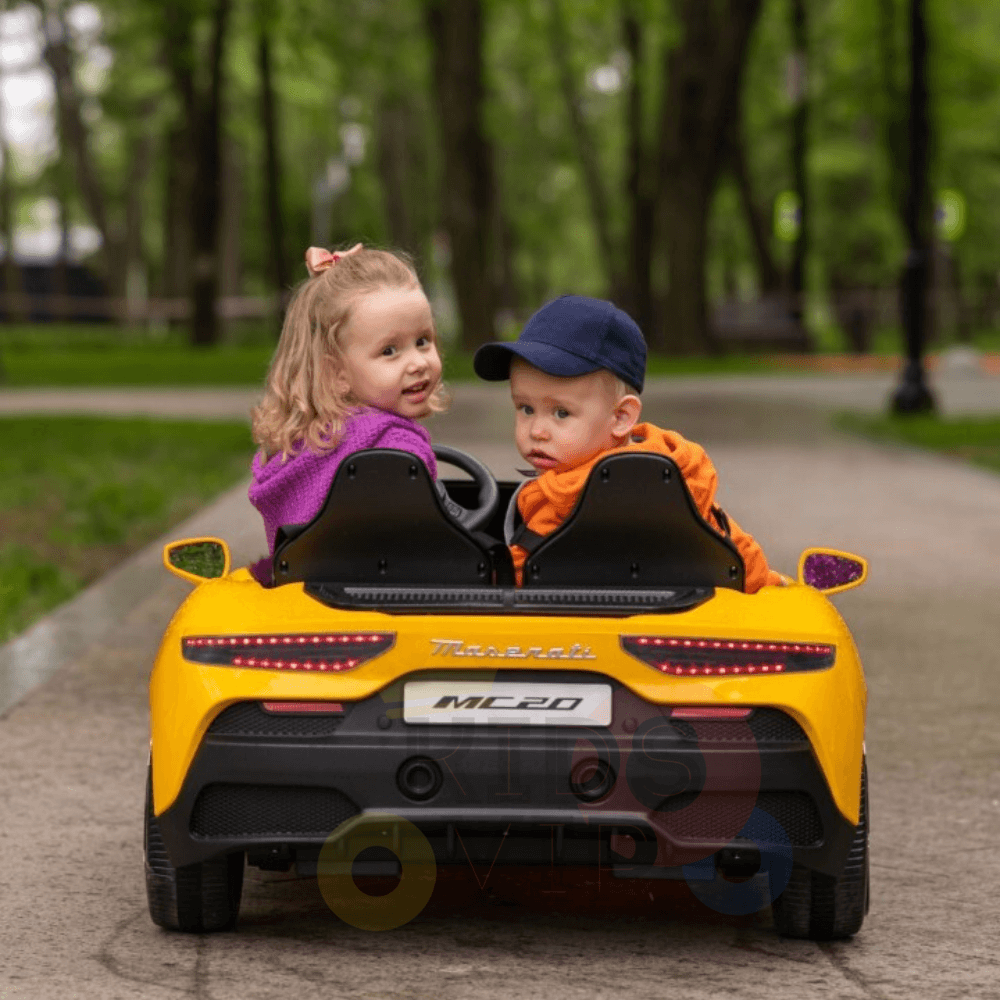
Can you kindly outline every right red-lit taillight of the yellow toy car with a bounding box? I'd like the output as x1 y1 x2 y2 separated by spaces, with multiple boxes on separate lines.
621 635 836 677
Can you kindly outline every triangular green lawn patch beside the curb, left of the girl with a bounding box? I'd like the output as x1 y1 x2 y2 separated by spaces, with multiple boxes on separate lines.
0 417 253 642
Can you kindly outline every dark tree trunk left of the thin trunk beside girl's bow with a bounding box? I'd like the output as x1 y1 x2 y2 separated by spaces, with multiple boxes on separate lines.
191 0 232 346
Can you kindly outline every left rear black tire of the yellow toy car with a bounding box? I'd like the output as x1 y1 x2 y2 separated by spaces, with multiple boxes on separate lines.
145 778 244 934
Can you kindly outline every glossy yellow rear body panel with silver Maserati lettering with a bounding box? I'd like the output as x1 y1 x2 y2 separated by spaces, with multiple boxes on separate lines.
150 569 867 826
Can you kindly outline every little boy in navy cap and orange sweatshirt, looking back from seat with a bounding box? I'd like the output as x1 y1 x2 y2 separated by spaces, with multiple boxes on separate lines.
473 295 783 594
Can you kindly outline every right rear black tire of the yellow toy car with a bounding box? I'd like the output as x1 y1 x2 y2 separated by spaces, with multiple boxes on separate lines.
771 762 869 941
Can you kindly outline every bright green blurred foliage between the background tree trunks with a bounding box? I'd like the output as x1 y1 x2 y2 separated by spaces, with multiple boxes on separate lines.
18 0 1000 348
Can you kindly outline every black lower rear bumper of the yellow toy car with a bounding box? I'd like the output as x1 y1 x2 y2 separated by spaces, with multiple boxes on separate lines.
153 685 854 874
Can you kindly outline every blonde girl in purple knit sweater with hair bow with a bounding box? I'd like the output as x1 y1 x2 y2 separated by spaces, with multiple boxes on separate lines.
250 243 444 585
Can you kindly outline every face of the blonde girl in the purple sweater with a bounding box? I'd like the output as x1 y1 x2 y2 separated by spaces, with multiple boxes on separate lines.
336 288 441 420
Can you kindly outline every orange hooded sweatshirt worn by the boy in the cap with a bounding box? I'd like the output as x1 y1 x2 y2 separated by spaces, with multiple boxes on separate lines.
510 424 783 594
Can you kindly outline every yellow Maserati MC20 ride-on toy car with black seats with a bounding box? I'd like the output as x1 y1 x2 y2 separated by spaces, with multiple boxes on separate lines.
146 449 868 939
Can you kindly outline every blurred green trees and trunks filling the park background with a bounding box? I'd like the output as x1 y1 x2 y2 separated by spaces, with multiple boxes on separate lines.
0 0 1000 352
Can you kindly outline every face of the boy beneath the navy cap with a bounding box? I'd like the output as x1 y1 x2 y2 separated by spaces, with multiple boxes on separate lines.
510 358 640 472
